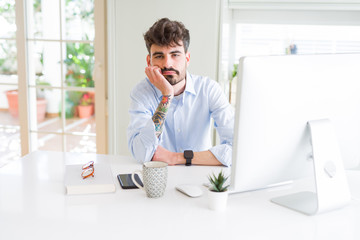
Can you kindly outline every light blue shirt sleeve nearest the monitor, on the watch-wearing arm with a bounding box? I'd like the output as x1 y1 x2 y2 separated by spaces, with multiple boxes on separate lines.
209 82 235 167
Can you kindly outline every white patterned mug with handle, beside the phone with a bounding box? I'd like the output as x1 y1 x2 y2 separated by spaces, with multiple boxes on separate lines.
131 162 168 198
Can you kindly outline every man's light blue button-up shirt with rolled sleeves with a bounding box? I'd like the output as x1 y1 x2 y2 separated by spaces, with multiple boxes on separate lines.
127 73 234 166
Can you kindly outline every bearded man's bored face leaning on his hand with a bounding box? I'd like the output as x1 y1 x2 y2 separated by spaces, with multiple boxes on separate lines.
146 43 190 86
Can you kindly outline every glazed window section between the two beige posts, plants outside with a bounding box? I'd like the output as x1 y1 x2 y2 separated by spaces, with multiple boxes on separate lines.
26 0 96 152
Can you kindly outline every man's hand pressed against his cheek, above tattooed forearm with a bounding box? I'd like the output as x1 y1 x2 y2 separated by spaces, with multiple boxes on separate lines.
145 66 174 96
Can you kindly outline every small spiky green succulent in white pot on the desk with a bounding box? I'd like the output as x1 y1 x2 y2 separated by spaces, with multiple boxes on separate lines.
208 171 229 211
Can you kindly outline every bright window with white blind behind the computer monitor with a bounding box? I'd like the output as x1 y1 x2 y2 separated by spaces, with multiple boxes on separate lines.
220 5 360 104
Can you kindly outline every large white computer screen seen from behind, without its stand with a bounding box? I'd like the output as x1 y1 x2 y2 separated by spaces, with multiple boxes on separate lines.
231 54 360 215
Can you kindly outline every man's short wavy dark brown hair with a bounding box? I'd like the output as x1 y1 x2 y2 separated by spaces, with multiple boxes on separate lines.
144 18 190 54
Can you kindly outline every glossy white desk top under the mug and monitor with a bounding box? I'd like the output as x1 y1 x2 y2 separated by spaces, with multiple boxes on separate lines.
0 152 360 240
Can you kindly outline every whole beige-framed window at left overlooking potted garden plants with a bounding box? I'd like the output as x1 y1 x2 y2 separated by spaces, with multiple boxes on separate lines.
0 0 106 166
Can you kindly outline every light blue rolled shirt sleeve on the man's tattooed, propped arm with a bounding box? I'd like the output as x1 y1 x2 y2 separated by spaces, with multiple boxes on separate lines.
127 87 159 163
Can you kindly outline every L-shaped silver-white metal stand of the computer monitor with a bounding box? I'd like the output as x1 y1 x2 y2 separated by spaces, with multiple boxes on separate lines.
271 119 351 215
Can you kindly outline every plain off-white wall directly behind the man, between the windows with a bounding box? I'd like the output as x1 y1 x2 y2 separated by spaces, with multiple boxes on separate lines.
108 0 221 155
